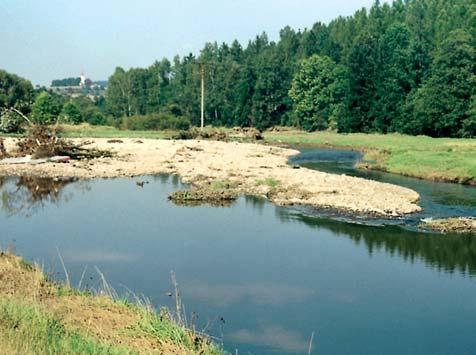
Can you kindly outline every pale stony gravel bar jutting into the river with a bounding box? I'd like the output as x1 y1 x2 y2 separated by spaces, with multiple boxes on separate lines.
0 138 420 217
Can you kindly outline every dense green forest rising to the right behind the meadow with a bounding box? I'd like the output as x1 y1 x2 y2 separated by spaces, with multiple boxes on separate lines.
0 0 476 137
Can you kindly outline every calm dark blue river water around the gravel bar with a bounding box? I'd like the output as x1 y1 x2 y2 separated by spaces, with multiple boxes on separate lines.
0 150 476 355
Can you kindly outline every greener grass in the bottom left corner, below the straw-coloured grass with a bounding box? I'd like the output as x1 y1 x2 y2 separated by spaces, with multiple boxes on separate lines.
0 299 133 355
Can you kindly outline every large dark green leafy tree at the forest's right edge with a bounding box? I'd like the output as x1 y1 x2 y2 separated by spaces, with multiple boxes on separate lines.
406 30 476 137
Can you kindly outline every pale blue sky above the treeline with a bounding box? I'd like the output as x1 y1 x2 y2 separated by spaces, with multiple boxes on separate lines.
0 0 384 85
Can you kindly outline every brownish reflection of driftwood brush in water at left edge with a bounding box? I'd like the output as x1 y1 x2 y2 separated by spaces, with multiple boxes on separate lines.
0 176 80 216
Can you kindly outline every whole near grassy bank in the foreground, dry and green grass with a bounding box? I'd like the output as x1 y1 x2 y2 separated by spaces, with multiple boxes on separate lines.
0 253 224 355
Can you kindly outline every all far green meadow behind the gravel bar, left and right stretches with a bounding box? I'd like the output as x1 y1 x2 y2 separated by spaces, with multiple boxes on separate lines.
3 124 476 185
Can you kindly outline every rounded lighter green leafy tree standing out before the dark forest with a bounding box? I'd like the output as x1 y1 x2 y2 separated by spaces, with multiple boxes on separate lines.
289 55 349 131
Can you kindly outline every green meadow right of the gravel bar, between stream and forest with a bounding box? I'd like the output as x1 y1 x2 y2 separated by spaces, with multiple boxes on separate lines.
265 130 476 184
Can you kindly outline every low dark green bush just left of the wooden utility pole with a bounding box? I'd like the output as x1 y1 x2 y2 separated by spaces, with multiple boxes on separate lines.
121 113 190 131
